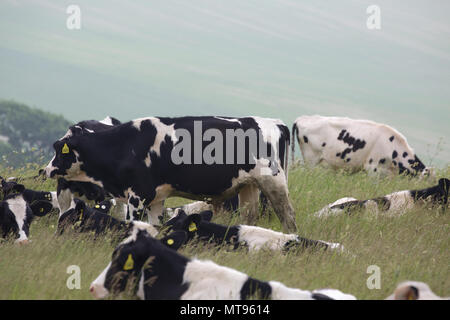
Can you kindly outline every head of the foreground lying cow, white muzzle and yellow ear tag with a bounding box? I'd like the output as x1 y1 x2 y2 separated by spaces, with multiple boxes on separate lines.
89 230 186 299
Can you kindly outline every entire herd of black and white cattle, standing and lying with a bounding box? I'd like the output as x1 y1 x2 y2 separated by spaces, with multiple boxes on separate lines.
0 116 450 300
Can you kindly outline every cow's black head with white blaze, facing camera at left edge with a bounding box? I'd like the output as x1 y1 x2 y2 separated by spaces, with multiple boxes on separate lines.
0 183 53 243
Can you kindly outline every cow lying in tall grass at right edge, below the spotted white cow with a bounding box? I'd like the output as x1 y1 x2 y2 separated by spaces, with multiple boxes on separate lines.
314 178 450 217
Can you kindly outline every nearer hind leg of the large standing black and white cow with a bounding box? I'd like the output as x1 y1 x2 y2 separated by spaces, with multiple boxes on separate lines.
256 171 297 232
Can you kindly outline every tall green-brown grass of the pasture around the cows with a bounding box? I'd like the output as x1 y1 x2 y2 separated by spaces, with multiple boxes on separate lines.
0 162 450 299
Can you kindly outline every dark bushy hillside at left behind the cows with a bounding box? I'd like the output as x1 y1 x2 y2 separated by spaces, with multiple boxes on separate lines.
0 100 71 167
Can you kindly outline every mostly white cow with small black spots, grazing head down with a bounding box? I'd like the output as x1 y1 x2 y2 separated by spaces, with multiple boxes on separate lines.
292 115 430 175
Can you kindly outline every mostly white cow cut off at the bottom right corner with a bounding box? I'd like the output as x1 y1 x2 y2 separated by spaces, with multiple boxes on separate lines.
386 281 450 300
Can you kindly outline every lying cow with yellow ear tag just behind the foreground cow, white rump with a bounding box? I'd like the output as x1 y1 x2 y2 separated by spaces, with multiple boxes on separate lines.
166 211 343 251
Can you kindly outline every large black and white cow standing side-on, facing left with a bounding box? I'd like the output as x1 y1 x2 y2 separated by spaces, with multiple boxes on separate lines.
45 117 296 231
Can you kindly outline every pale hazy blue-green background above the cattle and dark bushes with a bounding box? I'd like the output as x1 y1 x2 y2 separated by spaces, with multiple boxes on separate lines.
0 0 450 164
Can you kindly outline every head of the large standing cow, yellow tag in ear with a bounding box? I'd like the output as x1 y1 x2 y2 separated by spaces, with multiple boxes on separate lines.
44 132 81 178
